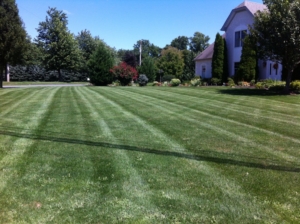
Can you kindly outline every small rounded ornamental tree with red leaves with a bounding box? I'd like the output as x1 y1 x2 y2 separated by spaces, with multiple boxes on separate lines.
110 62 138 86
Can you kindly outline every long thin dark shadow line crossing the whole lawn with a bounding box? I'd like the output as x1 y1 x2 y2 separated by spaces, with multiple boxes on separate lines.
0 130 300 173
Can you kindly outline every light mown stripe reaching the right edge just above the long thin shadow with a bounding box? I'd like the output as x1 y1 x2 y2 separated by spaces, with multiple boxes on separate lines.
96 89 299 165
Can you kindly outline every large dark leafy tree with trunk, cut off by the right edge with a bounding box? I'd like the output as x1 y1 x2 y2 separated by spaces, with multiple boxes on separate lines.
250 0 300 91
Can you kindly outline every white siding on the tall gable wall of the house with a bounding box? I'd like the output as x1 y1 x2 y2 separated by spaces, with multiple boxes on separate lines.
226 11 253 76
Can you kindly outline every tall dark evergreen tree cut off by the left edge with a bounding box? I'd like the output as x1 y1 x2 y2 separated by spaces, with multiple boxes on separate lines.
0 0 28 88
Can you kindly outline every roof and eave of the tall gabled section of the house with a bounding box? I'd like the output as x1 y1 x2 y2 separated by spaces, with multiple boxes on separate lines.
221 1 267 31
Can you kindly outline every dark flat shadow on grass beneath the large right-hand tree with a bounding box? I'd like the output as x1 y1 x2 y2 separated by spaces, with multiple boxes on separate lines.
217 88 286 96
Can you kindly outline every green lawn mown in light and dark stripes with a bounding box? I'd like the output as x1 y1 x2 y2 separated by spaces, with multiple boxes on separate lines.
0 87 300 223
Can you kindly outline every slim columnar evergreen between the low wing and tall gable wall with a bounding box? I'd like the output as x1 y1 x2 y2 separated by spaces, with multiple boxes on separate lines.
211 33 224 79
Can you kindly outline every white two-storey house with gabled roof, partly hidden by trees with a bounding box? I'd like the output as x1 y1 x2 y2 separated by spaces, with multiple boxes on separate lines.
194 1 282 80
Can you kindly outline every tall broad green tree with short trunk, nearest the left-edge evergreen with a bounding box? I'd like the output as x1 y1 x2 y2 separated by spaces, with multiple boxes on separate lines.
36 8 82 81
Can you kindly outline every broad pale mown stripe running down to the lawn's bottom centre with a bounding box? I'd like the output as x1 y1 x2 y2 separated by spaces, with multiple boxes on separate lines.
77 88 166 221
